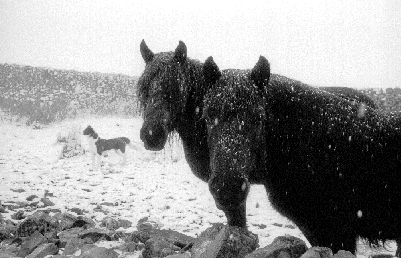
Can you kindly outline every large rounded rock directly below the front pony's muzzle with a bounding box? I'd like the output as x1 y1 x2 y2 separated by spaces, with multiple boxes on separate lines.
191 223 259 258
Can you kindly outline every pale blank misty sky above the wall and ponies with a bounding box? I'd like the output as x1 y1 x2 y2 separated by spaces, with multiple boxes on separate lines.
0 0 401 88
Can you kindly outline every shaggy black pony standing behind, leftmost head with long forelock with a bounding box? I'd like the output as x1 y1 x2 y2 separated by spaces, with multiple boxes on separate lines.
137 41 384 254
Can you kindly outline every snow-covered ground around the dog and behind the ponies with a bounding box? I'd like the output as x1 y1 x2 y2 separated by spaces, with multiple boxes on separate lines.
0 117 395 256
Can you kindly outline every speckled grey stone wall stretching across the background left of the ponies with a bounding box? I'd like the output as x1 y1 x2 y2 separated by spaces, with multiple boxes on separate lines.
0 64 137 124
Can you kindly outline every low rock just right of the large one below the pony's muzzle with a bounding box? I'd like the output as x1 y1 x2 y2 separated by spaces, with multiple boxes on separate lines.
245 236 308 258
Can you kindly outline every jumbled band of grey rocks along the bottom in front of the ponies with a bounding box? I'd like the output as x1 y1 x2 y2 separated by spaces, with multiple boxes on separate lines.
0 196 355 258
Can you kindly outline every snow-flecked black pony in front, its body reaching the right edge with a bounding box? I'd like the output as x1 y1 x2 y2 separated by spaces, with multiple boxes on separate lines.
203 57 401 254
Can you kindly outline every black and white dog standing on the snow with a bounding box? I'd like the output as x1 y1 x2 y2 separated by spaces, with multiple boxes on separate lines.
83 125 135 170
